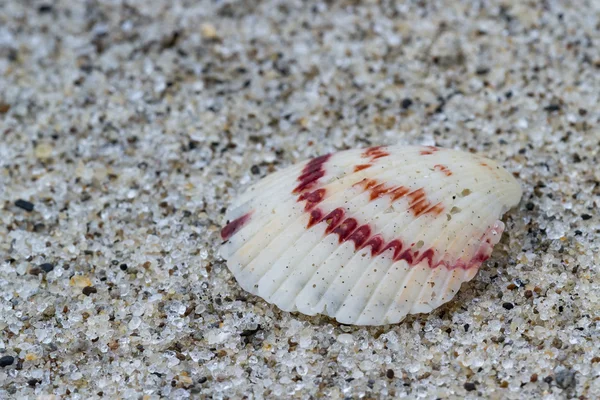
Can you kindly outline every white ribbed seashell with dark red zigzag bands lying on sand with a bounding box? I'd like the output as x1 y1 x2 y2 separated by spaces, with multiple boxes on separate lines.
221 146 521 325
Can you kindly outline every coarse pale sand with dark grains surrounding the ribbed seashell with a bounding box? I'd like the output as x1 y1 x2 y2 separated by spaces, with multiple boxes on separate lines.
0 0 600 399
